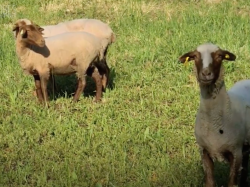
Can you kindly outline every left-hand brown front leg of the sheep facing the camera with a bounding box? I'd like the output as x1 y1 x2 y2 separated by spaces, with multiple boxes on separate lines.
202 149 215 187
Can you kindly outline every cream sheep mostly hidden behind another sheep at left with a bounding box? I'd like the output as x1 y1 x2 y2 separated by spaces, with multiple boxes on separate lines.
42 19 115 89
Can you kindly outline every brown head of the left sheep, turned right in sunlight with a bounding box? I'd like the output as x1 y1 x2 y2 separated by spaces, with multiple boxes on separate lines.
12 19 45 47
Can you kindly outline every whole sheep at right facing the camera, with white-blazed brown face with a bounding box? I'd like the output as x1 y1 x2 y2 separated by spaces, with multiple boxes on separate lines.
180 43 250 187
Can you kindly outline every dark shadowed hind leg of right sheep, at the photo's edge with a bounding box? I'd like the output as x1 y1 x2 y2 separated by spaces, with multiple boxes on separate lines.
240 145 249 187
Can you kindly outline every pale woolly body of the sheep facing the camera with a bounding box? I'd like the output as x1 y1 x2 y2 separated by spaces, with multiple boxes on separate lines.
195 80 250 161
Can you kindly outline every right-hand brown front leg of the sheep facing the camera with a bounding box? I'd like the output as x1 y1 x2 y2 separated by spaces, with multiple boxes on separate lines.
228 150 242 187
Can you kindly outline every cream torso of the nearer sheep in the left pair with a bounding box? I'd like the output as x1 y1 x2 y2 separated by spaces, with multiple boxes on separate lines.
17 32 102 76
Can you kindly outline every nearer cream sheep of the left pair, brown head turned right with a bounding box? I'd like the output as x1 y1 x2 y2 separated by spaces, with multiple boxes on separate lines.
13 19 103 103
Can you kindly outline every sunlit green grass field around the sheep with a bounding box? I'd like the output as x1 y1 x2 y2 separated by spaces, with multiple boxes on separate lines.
0 0 250 187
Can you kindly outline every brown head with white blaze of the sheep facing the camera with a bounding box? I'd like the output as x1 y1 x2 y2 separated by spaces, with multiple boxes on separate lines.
179 43 236 85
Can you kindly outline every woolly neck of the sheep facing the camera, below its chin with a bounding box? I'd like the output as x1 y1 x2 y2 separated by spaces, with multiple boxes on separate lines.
199 69 231 131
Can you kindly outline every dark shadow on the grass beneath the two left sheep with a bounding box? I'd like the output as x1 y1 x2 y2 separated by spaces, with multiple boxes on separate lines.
48 68 116 100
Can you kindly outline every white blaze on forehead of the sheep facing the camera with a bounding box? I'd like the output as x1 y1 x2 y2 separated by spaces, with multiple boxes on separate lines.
197 43 219 68
